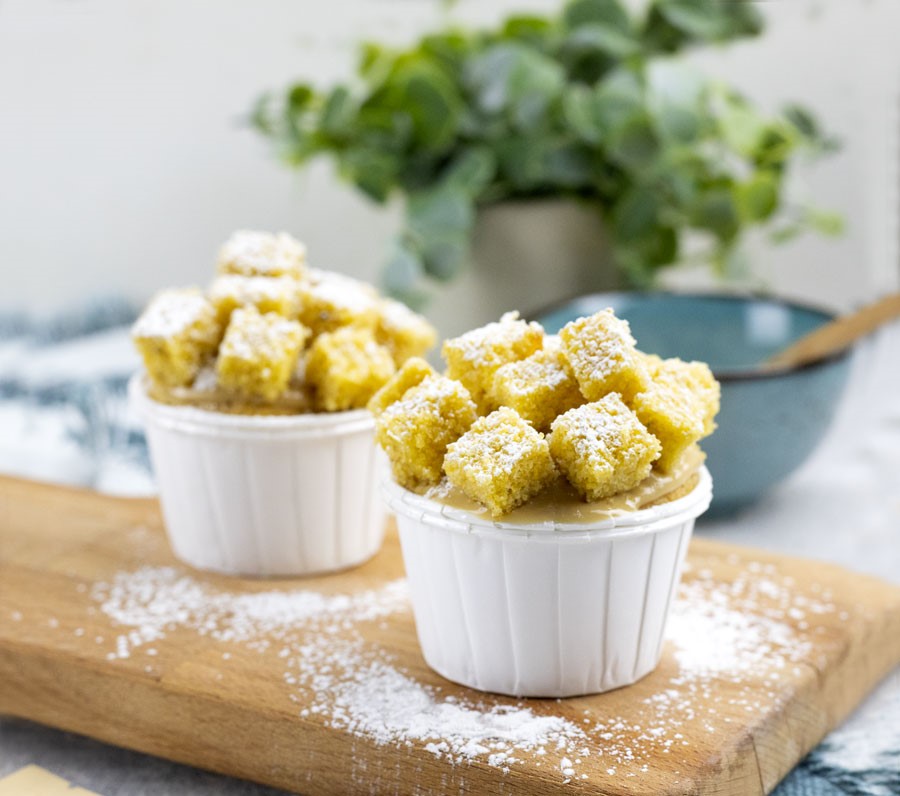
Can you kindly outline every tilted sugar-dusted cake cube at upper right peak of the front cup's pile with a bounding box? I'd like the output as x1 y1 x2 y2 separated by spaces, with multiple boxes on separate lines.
559 309 649 401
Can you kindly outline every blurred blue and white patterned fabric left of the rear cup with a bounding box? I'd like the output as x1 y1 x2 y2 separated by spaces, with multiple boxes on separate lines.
0 299 153 494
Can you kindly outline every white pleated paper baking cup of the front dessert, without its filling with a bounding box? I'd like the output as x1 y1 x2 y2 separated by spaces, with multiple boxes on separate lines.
383 468 712 697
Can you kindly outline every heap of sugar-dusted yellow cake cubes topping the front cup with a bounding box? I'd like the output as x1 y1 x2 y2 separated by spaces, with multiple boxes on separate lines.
369 310 719 517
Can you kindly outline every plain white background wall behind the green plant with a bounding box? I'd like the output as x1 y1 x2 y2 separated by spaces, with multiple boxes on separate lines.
0 0 900 320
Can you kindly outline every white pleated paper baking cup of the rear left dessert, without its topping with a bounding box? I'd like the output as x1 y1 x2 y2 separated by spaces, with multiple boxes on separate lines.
129 375 385 576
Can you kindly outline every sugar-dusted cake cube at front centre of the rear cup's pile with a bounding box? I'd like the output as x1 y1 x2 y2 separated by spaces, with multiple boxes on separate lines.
216 307 310 402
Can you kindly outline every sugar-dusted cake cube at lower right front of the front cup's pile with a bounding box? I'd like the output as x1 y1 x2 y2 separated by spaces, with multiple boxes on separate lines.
549 393 661 501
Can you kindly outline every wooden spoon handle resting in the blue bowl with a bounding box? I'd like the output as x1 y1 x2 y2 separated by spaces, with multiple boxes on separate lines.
765 293 900 370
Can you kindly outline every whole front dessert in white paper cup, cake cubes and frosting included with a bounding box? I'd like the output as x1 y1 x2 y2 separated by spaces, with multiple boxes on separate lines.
369 310 719 697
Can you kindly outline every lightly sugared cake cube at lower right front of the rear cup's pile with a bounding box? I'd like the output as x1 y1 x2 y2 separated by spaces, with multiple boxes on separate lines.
306 326 394 412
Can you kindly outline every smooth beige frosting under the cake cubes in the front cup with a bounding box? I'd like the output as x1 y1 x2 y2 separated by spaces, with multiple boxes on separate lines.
424 445 706 525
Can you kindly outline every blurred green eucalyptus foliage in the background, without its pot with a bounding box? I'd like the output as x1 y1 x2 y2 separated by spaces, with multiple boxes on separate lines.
252 0 839 303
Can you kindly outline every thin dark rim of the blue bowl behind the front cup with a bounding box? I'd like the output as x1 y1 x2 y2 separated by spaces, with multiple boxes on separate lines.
526 290 853 382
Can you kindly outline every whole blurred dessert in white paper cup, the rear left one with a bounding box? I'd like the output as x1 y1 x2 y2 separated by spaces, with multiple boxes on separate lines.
129 232 435 576
